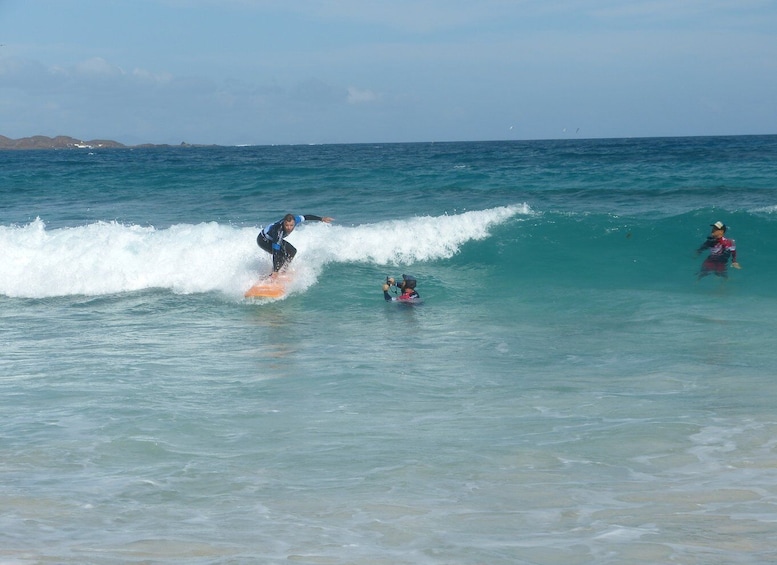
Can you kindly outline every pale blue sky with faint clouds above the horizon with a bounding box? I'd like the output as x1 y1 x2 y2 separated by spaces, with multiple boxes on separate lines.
0 0 777 145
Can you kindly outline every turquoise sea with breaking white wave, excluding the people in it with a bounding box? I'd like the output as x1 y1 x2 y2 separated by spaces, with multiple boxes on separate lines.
0 135 777 565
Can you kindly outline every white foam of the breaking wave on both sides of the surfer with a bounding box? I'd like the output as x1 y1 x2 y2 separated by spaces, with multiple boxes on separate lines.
0 205 531 298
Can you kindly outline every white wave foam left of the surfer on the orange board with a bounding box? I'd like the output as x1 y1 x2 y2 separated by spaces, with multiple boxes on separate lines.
0 219 257 298
